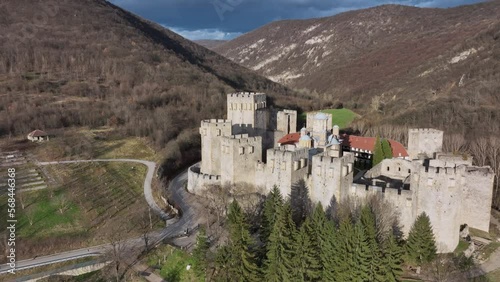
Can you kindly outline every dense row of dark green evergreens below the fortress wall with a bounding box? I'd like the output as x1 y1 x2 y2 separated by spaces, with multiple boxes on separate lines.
193 187 442 282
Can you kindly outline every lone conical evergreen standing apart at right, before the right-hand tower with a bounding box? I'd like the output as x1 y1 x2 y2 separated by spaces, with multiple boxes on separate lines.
406 212 437 264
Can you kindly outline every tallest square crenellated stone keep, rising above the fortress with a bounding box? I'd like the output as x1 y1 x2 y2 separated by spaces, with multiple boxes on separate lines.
227 92 268 134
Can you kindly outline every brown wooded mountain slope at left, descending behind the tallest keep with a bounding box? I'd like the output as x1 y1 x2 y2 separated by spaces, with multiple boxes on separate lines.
0 0 301 145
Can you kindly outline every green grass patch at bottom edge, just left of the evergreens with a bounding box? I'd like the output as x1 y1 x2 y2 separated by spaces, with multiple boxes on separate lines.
147 245 204 282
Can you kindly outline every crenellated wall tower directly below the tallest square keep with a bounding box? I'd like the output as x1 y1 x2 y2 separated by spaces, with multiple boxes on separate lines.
220 134 262 184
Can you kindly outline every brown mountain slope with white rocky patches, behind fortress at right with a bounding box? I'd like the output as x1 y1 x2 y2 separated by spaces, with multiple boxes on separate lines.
215 1 500 132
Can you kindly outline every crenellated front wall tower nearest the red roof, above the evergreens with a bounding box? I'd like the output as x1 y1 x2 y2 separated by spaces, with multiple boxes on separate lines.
309 152 354 207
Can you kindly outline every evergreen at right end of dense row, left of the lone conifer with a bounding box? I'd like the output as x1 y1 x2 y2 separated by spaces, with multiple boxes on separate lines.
378 233 403 282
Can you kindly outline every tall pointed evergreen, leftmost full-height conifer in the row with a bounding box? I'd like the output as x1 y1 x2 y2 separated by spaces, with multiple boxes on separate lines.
228 200 258 281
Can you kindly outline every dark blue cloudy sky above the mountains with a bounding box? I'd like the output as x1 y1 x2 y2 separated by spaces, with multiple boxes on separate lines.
109 0 481 40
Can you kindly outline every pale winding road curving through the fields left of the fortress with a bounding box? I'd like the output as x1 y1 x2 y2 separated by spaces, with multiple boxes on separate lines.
0 162 193 274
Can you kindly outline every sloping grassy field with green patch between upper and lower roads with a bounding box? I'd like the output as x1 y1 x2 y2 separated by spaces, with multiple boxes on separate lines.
0 160 162 262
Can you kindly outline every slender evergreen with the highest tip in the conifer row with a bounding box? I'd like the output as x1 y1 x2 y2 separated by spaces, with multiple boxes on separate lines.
260 185 283 245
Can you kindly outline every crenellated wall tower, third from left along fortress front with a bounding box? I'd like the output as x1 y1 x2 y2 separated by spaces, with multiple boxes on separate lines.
266 148 309 197
